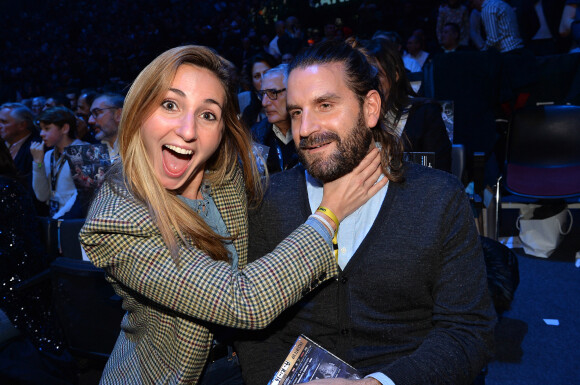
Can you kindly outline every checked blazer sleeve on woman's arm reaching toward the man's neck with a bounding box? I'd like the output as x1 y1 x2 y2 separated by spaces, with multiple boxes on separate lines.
80 185 337 329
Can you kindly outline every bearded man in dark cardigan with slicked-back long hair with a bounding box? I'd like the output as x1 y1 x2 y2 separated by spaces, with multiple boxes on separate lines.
236 41 496 385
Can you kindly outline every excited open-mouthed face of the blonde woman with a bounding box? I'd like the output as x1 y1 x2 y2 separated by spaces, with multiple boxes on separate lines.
141 64 226 199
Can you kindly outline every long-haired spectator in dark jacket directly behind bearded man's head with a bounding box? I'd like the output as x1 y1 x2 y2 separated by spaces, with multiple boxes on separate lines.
353 39 451 172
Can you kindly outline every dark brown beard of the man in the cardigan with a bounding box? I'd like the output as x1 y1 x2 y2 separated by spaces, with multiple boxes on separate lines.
298 111 373 183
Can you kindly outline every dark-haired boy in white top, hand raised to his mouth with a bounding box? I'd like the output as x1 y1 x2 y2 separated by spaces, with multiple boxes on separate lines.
30 107 86 219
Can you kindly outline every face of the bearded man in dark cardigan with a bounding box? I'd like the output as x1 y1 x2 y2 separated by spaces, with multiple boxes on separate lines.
287 63 380 182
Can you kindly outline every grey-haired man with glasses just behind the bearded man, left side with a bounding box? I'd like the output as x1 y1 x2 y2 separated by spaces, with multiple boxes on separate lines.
252 64 298 174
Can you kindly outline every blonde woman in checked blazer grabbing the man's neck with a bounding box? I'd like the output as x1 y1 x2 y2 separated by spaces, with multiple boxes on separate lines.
80 46 386 384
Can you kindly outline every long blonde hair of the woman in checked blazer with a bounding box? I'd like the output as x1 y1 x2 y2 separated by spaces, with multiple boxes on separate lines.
119 45 262 263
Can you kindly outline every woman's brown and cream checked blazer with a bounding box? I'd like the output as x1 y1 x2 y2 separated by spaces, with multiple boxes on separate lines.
80 164 338 384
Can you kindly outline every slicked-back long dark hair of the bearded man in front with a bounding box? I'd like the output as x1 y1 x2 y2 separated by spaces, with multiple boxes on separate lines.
288 41 404 182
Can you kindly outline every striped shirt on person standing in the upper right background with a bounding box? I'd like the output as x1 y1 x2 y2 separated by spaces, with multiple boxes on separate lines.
481 0 524 52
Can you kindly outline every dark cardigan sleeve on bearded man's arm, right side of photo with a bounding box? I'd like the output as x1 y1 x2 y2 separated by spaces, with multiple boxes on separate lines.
381 181 496 385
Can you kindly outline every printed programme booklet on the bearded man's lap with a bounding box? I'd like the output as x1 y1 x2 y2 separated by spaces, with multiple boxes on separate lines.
269 335 362 385
